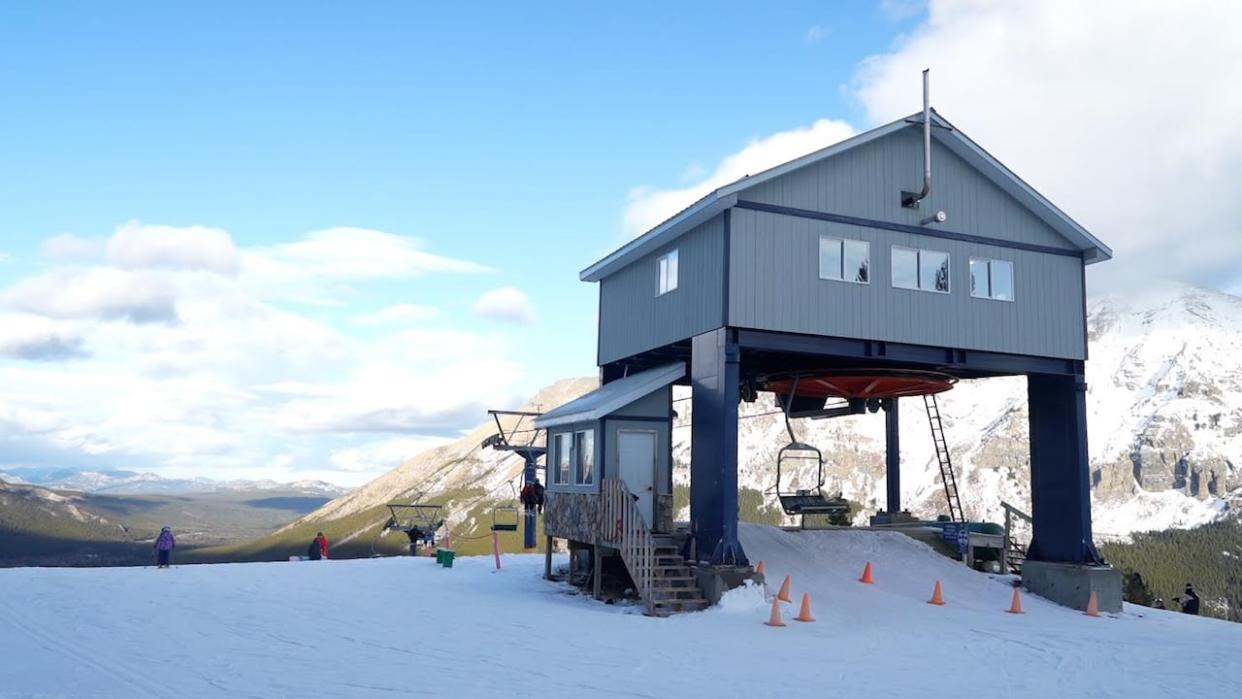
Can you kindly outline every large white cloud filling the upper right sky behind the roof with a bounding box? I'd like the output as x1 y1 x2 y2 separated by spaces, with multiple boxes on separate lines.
854 0 1242 287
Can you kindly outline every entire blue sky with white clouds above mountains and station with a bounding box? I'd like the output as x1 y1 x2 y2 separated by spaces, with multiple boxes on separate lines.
0 0 1242 482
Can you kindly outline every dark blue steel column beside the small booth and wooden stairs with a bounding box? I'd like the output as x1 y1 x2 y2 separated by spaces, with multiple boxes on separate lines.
691 328 746 565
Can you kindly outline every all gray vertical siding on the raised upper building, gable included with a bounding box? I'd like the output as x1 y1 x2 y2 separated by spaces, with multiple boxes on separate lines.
599 128 1086 365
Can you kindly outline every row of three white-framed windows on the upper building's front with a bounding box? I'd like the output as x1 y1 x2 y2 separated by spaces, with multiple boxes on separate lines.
820 236 1013 300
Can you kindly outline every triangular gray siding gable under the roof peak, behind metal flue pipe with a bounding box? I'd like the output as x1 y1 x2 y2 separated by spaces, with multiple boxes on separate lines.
739 125 1074 250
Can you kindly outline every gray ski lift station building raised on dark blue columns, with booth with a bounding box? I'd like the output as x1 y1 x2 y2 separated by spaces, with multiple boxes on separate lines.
537 101 1120 608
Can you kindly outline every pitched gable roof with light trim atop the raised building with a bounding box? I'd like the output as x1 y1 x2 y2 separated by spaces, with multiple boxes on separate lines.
579 109 1113 282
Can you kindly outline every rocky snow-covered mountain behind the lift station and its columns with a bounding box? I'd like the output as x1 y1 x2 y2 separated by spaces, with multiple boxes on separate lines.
276 284 1242 548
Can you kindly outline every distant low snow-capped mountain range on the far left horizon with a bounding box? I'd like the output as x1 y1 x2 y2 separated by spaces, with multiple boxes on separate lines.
0 467 349 498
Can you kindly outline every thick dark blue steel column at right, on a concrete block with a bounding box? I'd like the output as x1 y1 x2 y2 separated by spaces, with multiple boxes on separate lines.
1026 374 1102 564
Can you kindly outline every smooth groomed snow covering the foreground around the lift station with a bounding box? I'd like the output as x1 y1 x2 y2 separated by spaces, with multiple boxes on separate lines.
0 526 1242 699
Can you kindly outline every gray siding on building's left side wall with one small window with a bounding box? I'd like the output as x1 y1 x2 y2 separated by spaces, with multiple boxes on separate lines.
599 216 724 365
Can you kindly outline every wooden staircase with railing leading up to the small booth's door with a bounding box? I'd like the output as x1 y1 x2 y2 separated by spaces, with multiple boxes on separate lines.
599 478 708 616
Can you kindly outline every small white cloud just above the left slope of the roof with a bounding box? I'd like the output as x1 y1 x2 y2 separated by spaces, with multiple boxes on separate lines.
623 119 854 237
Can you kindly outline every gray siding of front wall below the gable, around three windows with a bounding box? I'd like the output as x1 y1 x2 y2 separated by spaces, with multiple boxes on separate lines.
729 210 1086 359
